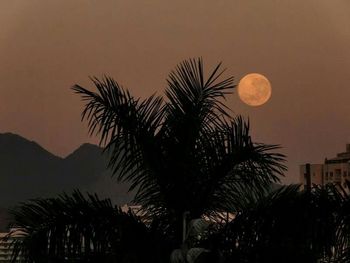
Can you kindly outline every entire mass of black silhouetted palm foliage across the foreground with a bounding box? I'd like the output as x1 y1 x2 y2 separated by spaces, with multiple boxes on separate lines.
6 59 349 263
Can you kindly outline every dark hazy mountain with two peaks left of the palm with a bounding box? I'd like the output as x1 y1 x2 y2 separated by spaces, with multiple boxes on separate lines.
0 133 132 228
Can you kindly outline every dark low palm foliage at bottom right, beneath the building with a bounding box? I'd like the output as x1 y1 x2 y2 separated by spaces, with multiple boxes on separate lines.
215 185 350 263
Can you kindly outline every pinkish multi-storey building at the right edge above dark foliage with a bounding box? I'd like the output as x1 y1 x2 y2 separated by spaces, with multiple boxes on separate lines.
300 144 350 188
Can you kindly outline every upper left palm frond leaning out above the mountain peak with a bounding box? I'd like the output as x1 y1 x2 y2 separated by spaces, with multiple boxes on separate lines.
73 77 163 186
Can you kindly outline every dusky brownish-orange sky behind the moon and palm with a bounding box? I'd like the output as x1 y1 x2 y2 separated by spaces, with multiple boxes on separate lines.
0 0 350 183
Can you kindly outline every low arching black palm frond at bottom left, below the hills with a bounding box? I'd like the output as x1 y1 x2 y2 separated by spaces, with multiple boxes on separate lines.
5 191 167 262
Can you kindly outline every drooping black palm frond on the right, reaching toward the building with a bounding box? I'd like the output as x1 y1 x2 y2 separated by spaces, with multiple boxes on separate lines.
185 116 286 217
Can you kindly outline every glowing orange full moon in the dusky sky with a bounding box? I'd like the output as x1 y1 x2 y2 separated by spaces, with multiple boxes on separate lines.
238 73 271 106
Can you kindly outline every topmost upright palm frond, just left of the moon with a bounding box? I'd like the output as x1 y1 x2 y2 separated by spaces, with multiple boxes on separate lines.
165 58 235 143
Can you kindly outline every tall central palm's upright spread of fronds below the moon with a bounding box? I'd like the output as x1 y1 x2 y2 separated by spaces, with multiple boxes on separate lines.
6 59 285 262
